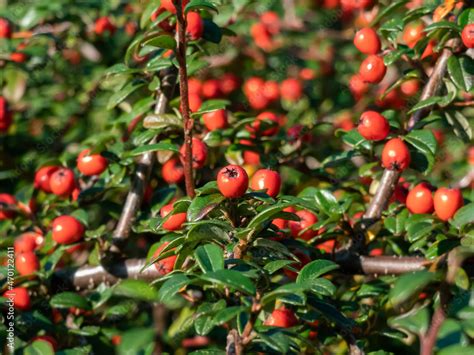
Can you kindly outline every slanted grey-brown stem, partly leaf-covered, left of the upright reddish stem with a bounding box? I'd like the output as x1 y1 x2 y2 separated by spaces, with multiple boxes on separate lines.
112 71 176 248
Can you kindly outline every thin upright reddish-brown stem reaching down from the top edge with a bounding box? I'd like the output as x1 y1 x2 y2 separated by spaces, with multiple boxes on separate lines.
175 0 196 198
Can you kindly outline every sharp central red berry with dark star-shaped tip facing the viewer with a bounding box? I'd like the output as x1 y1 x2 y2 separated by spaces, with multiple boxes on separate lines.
217 165 249 198
